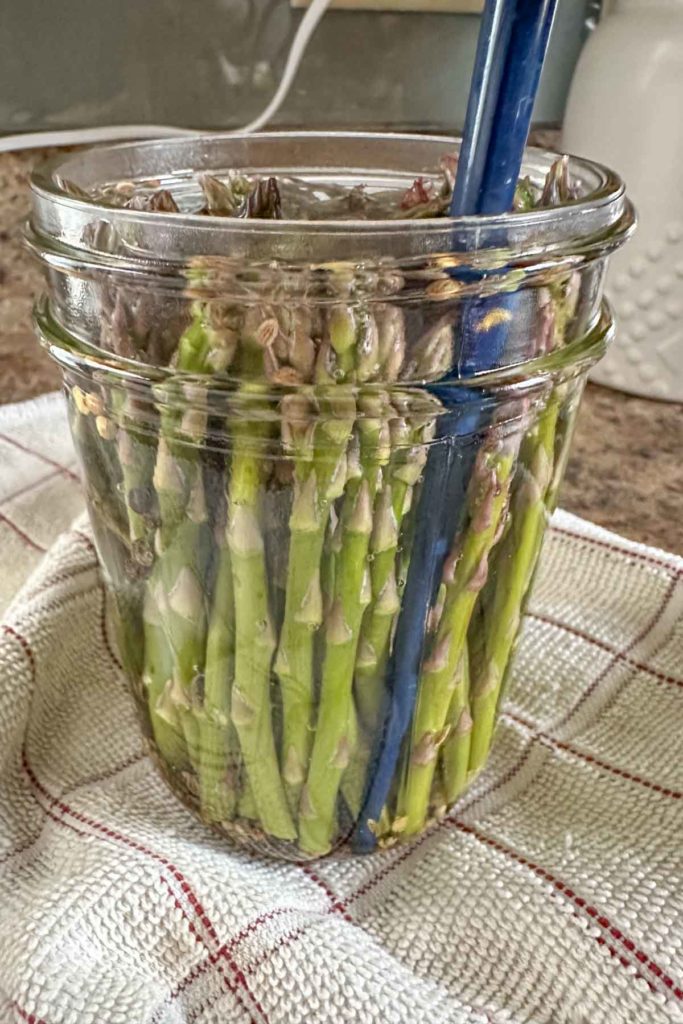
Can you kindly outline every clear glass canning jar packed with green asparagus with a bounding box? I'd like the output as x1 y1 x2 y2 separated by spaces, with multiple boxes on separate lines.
28 133 633 860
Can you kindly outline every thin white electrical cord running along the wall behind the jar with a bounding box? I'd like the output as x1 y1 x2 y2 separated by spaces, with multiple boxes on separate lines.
0 0 331 153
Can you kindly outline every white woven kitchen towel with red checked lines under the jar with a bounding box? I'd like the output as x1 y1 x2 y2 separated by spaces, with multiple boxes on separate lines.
0 397 683 1024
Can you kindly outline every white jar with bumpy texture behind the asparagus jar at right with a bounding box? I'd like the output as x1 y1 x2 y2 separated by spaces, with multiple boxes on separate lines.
563 0 683 401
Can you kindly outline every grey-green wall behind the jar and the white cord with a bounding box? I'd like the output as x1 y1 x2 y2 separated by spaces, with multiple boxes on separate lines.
0 0 600 132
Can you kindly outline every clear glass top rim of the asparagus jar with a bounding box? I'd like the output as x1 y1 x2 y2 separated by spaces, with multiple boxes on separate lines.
29 132 634 268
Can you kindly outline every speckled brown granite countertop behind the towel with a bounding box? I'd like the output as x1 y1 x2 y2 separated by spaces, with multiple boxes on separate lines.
0 151 683 553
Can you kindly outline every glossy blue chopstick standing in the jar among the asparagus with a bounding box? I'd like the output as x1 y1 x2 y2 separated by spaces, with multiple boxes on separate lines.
354 0 557 852
